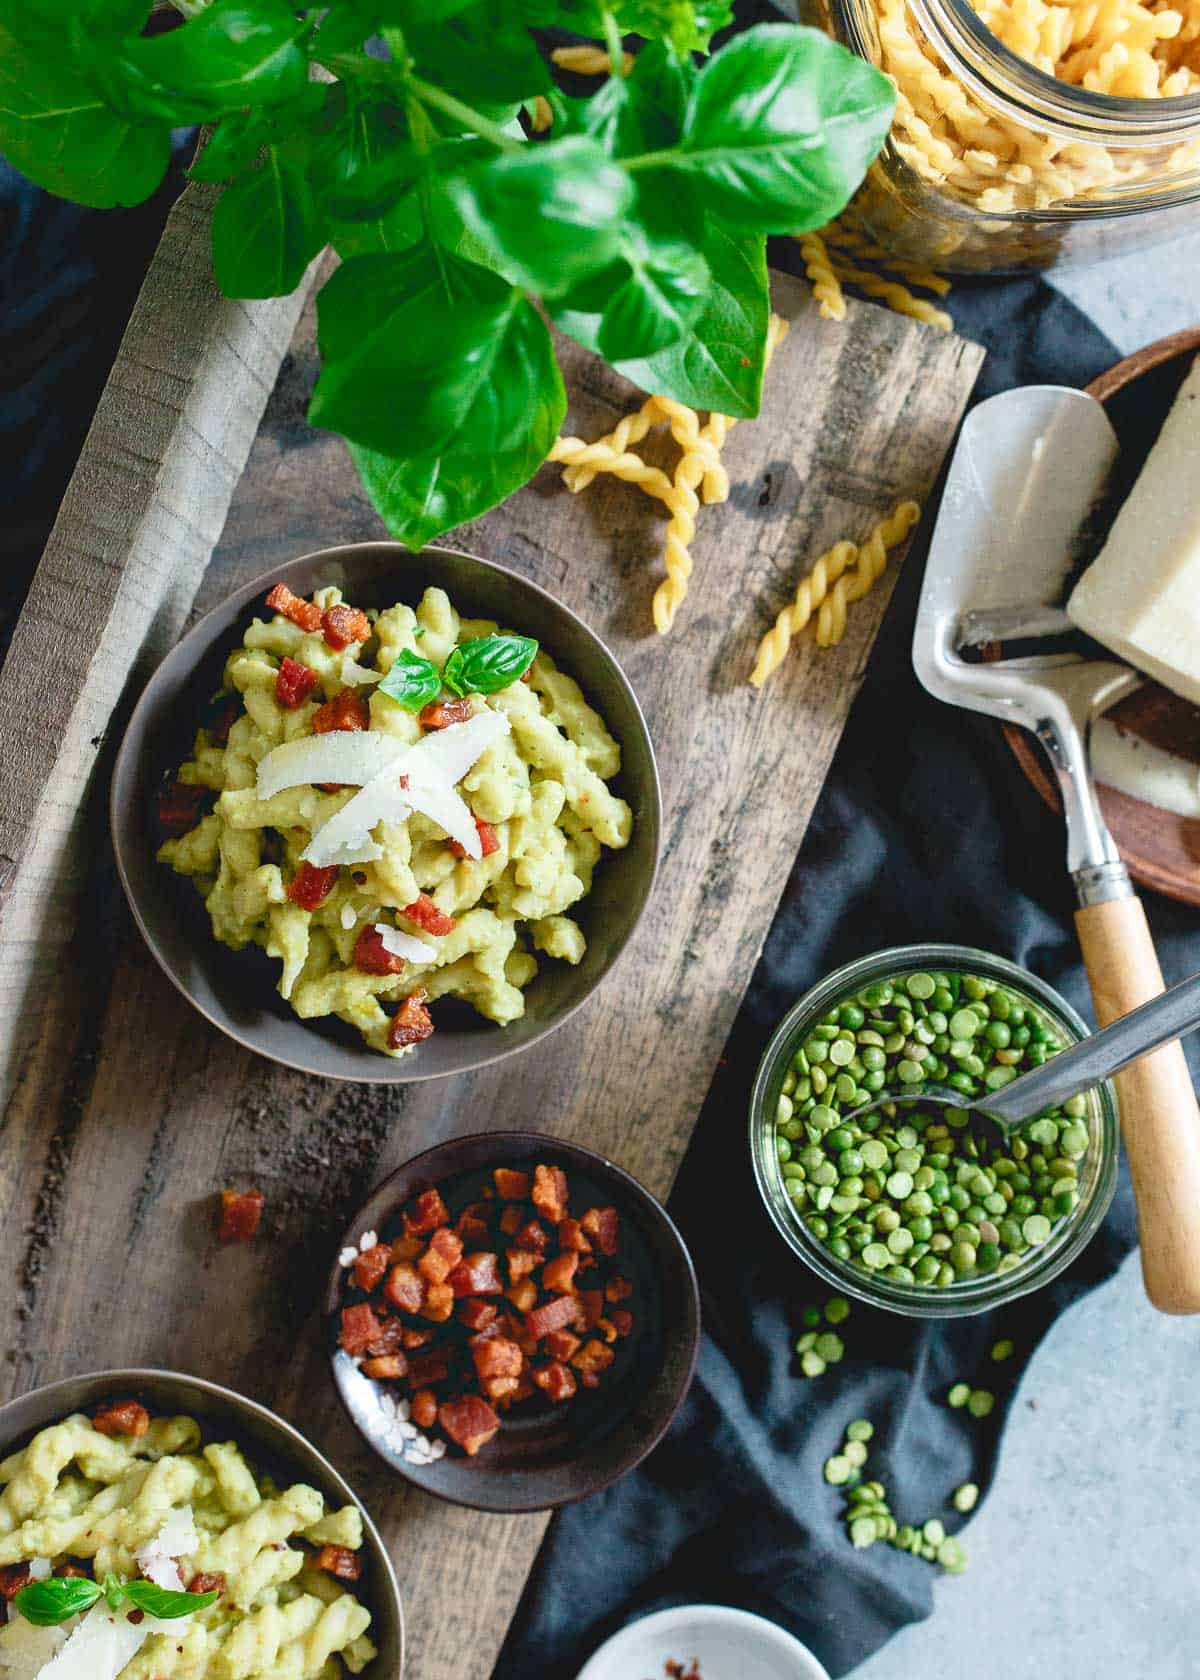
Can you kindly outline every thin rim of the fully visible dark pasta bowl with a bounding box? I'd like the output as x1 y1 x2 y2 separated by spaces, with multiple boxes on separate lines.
108 539 662 1085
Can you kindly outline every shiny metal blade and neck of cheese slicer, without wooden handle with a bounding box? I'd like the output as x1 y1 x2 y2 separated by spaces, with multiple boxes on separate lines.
913 385 1141 904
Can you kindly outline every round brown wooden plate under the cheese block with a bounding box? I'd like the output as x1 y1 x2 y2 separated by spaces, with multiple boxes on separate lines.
1005 328 1200 906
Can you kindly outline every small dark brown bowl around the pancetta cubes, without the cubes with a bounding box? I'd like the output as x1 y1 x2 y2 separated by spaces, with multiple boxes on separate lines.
324 1132 699 1512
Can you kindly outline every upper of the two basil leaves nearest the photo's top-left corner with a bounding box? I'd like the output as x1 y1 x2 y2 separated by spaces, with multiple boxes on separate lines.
94 0 308 124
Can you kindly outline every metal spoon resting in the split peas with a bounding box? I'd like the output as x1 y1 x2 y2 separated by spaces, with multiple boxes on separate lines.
859 974 1200 1142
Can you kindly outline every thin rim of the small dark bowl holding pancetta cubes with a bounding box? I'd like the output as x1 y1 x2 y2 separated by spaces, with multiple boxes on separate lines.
321 1131 701 1517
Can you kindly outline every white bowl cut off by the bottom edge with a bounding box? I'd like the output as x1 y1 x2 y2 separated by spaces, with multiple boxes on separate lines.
578 1604 829 1680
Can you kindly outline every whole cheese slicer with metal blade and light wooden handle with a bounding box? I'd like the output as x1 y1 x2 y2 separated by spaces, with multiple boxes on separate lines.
913 385 1200 1312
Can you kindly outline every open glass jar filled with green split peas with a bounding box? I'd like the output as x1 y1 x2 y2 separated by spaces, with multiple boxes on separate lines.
750 944 1119 1319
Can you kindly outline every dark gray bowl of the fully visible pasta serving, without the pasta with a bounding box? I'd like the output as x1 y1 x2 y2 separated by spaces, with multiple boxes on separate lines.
111 543 662 1084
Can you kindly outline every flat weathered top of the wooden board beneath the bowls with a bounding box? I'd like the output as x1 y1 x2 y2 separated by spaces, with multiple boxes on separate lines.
0 268 982 1680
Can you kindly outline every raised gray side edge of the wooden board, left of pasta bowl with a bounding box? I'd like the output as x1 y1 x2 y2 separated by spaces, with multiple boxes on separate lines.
0 185 317 1089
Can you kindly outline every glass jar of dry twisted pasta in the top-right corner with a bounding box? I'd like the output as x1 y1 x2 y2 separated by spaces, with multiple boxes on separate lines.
807 0 1200 274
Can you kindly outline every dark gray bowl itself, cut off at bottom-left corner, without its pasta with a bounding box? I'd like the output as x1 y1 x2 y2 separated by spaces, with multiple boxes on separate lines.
0 1368 403 1680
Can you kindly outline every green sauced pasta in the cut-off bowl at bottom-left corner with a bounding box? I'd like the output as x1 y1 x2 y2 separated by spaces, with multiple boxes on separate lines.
0 1399 376 1680
